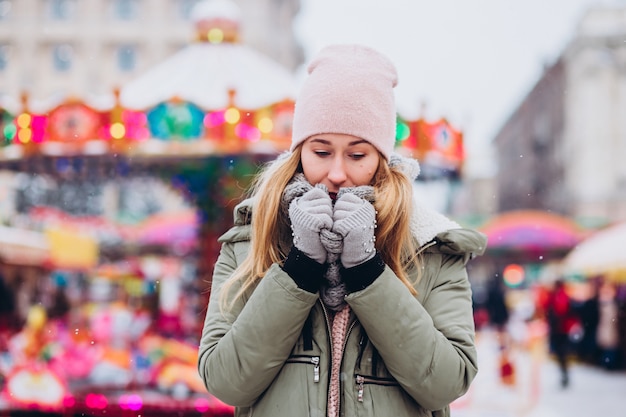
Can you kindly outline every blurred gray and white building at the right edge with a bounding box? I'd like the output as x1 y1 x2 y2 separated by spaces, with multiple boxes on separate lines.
494 7 626 225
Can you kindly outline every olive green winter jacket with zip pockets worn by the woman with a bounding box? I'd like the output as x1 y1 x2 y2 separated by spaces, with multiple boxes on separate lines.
198 200 486 417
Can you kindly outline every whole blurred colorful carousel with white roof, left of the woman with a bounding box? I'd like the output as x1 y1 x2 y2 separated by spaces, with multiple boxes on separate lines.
0 0 296 415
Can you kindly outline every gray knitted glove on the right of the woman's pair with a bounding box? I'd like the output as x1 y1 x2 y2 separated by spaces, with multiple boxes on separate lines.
332 193 376 268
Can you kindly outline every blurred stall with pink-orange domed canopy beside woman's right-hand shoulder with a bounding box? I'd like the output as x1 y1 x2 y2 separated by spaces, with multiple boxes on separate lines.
471 210 589 334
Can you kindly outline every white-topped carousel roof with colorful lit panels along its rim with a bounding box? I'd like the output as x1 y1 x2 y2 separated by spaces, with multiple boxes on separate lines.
0 0 296 160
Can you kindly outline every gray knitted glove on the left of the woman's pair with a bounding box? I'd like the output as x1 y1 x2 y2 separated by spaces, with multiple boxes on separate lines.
289 187 333 264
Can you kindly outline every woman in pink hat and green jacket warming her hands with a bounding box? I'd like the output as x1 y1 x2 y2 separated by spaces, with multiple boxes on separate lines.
199 45 485 417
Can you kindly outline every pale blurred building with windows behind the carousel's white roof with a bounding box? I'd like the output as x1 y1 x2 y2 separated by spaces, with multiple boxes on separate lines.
0 0 304 98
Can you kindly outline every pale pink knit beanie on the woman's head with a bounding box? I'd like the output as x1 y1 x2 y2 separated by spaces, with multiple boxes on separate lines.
291 45 398 160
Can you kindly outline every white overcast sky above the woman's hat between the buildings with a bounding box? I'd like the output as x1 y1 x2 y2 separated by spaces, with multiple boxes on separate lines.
295 0 626 176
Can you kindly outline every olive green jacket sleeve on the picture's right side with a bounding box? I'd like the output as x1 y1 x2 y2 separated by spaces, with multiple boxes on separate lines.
347 254 477 410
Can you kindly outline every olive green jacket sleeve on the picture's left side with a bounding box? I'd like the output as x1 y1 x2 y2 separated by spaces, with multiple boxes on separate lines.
198 243 318 406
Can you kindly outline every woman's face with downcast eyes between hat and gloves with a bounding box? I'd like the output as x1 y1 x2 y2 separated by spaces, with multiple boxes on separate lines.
301 133 380 196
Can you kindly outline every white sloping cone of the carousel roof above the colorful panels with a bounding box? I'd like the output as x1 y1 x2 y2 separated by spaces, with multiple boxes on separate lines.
120 42 297 111
